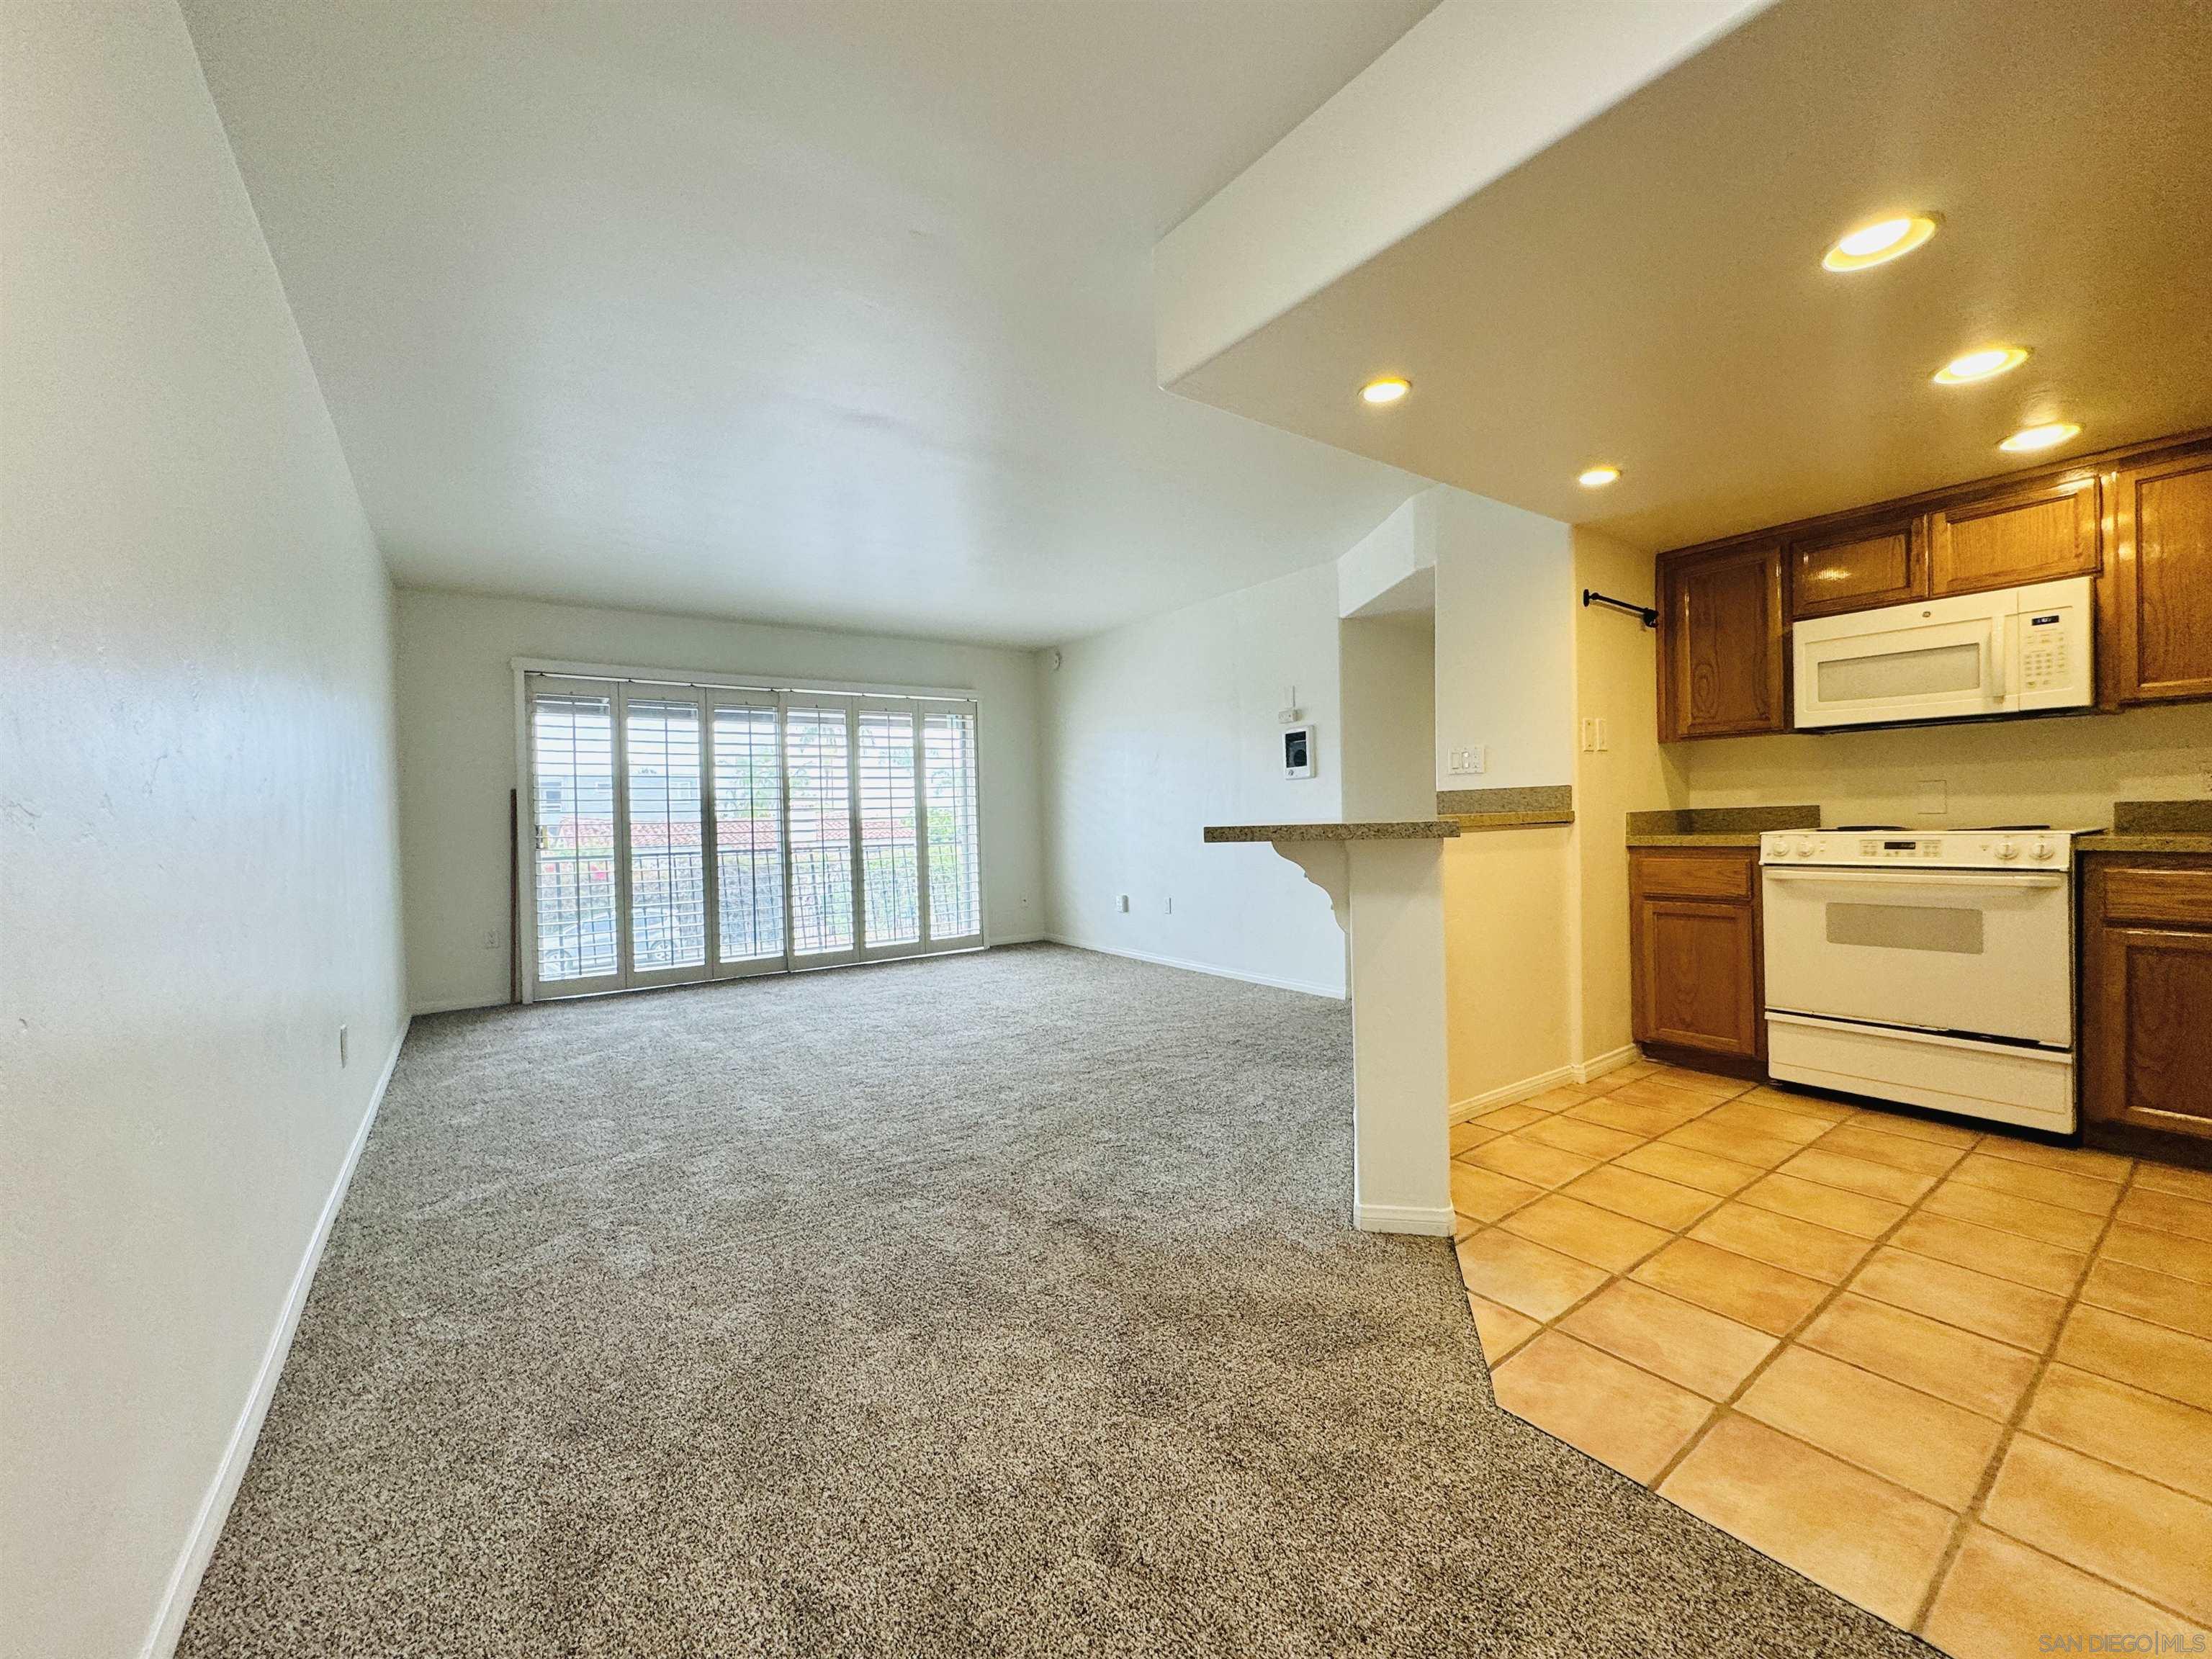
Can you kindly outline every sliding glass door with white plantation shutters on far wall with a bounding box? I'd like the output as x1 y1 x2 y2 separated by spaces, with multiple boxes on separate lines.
524 675 982 995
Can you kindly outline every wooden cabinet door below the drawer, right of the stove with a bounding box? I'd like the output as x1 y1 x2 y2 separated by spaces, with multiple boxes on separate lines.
2082 927 2212 1137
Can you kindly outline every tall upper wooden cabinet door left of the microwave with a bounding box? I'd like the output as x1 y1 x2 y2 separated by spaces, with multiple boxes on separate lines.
1659 542 1789 743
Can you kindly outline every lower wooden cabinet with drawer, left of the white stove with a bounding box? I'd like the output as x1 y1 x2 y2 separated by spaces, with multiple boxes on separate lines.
1628 848 1768 1071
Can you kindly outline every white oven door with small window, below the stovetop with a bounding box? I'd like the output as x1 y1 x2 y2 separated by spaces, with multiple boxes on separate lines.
1763 867 2072 1048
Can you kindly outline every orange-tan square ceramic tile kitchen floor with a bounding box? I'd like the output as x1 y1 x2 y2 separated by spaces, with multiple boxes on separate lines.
1451 1062 2212 1659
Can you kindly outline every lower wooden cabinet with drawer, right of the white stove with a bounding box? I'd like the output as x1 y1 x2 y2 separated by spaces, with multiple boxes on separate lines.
2082 854 2212 1139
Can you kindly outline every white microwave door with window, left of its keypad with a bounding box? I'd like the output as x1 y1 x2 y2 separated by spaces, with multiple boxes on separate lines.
1789 590 2020 730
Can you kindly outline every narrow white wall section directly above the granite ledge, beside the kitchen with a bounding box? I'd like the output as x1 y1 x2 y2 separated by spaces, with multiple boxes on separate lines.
1416 485 1575 790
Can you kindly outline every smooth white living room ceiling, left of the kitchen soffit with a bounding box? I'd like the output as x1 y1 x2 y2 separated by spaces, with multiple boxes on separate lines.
186 0 1431 644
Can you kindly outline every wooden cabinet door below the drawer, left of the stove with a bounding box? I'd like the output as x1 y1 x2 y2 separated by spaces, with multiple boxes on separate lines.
1632 898 1765 1057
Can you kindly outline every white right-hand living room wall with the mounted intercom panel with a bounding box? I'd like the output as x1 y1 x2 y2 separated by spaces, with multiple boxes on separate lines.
1038 564 1345 995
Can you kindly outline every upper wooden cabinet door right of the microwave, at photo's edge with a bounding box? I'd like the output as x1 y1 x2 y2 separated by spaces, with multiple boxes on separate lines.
2108 451 2212 703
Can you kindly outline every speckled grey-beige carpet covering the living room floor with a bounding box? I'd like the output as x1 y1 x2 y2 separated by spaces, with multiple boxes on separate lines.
181 947 1927 1659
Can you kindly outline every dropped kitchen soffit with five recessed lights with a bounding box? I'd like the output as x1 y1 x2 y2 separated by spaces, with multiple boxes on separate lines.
1155 0 2212 559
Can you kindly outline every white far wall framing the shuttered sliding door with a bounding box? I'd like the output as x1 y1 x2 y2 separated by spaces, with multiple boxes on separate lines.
398 588 1044 1011
